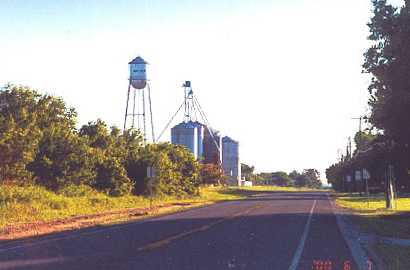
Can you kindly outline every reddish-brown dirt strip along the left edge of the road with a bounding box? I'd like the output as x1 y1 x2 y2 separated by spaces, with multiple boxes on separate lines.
0 203 197 241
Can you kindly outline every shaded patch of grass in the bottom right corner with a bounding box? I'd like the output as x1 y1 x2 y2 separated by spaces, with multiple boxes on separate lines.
373 244 410 270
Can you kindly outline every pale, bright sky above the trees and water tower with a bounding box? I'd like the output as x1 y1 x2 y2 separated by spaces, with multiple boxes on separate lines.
0 0 403 179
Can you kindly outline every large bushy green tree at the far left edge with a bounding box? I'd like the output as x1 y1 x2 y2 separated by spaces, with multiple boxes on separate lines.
0 85 92 188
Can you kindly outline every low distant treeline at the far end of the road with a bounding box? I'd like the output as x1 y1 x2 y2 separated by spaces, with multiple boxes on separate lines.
241 164 322 188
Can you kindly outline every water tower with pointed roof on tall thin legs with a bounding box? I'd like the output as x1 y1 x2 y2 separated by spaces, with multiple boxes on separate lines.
124 56 155 142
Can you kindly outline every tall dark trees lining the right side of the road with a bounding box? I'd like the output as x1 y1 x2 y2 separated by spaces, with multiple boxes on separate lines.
326 0 410 192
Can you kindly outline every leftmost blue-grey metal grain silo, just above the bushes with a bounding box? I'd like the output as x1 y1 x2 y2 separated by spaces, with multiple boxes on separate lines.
171 121 198 159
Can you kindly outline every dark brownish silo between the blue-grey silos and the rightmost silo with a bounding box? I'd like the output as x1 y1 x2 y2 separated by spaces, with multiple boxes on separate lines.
203 127 222 165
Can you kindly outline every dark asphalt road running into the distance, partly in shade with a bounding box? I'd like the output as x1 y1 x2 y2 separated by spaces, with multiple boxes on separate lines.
0 192 357 270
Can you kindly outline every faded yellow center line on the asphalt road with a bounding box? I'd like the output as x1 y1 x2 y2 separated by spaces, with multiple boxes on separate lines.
137 204 262 251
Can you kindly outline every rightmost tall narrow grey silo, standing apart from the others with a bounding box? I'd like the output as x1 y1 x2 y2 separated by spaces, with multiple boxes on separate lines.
222 136 241 186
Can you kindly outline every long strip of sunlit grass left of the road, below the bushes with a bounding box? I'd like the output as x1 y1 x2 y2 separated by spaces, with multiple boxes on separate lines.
0 185 318 228
